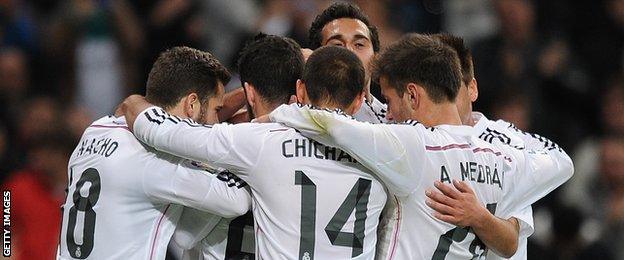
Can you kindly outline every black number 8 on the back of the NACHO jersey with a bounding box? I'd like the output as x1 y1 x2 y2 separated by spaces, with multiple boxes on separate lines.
66 168 100 259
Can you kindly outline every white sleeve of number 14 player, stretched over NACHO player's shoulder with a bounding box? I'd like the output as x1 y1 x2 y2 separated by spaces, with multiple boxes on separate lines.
133 107 260 175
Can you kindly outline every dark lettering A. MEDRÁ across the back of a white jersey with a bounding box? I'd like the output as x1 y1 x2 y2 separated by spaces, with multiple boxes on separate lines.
440 162 503 189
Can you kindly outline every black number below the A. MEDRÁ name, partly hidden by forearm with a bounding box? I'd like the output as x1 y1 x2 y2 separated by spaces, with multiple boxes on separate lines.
431 203 496 260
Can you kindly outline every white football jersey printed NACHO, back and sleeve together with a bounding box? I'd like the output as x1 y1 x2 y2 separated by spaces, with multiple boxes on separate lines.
57 117 251 259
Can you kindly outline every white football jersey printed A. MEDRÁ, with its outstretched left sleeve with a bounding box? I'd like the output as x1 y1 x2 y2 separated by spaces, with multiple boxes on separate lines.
270 104 572 259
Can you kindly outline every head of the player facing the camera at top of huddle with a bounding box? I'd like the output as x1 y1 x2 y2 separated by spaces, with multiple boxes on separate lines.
308 2 380 84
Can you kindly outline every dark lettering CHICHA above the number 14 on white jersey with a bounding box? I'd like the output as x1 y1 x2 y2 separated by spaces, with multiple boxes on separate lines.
282 138 357 163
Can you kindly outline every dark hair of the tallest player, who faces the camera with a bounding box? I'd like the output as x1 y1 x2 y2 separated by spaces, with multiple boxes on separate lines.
308 2 379 52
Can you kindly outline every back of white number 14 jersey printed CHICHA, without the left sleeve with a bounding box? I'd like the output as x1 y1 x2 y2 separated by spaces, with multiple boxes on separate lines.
219 123 386 259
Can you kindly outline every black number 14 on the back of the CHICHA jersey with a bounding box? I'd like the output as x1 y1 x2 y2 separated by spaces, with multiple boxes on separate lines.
295 171 372 260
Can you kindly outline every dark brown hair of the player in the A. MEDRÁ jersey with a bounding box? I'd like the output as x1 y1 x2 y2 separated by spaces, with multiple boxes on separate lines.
373 33 461 103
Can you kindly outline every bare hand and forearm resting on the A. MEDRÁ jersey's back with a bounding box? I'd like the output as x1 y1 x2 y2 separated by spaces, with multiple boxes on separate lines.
425 180 520 258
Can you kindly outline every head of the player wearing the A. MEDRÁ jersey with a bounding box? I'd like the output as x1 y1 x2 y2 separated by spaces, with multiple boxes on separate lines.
374 33 461 121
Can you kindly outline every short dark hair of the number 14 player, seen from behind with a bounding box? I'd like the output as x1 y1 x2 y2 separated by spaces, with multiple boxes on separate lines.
302 46 365 108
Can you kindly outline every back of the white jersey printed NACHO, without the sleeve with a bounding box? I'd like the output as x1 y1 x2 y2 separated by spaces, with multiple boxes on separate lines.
59 117 181 259
